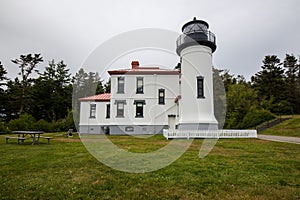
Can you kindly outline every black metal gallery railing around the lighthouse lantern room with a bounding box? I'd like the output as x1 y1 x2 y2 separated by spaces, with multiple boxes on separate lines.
176 31 216 47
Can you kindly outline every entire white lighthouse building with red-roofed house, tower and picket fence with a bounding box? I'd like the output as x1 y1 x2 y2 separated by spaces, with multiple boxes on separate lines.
79 18 256 138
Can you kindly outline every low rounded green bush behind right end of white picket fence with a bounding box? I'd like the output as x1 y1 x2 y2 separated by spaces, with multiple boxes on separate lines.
238 109 276 129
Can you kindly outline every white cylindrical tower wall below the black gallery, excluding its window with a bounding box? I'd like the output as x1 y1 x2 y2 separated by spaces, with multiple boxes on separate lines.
179 45 217 124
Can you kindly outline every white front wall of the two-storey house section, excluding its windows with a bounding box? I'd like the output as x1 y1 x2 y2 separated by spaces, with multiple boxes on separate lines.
110 74 179 125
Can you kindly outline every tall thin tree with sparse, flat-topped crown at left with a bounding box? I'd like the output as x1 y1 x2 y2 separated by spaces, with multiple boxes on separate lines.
11 54 43 115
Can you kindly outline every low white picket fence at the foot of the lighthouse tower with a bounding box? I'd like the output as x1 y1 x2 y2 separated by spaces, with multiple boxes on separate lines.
163 129 257 139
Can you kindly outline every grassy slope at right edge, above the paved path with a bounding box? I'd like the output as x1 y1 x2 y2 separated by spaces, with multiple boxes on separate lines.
261 115 300 137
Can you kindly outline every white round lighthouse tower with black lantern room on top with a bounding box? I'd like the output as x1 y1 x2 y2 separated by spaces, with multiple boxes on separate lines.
176 18 218 130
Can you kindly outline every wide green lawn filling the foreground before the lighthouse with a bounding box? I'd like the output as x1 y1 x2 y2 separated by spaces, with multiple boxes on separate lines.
0 135 300 199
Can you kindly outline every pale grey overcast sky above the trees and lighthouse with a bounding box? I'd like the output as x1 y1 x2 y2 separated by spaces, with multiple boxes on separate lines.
0 0 300 79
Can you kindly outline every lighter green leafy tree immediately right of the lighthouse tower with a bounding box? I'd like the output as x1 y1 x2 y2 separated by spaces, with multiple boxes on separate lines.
213 69 259 128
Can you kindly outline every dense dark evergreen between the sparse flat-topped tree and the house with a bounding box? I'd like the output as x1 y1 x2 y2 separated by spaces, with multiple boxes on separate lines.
31 60 72 121
